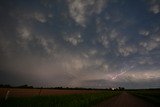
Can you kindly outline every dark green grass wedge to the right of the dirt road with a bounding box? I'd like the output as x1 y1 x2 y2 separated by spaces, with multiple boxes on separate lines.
129 90 160 105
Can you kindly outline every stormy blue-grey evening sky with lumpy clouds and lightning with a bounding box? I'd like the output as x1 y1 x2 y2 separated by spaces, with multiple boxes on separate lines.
0 0 160 88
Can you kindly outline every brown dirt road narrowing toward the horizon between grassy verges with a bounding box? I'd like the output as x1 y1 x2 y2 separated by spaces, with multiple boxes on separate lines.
94 92 158 107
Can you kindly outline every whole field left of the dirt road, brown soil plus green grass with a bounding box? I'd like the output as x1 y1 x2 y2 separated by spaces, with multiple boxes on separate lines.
0 89 120 107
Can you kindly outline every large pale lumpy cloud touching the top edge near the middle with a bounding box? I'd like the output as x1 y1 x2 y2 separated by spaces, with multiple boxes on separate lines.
68 0 106 27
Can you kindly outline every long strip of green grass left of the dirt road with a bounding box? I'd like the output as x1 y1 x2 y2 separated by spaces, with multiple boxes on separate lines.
0 91 120 107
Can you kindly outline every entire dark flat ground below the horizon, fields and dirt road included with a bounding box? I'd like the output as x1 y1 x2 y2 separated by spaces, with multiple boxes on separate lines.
0 88 160 107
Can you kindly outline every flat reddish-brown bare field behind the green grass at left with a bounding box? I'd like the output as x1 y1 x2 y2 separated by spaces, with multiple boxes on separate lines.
0 88 97 98
